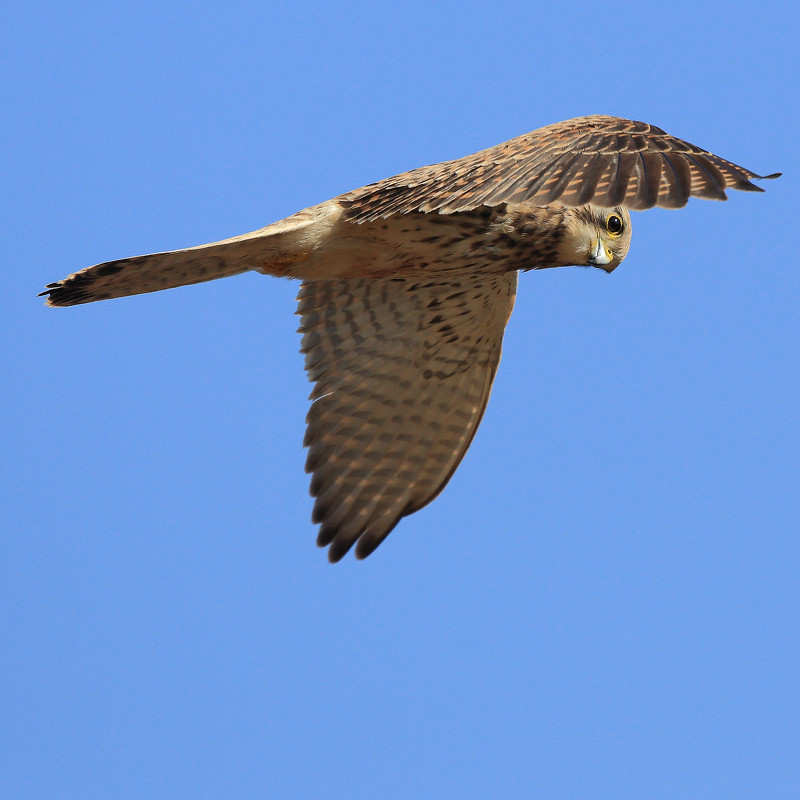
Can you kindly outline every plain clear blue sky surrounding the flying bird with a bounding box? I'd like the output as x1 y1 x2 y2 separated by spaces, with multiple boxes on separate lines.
0 0 800 800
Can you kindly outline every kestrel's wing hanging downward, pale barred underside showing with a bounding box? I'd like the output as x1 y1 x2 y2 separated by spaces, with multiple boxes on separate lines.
297 272 517 561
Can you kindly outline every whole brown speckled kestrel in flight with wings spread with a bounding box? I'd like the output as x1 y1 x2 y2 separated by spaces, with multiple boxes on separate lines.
40 115 780 562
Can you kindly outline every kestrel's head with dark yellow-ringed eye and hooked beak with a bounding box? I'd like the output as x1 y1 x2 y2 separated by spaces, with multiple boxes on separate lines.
559 206 631 272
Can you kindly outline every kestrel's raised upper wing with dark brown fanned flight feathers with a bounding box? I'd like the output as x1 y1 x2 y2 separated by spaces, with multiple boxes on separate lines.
340 116 780 222
